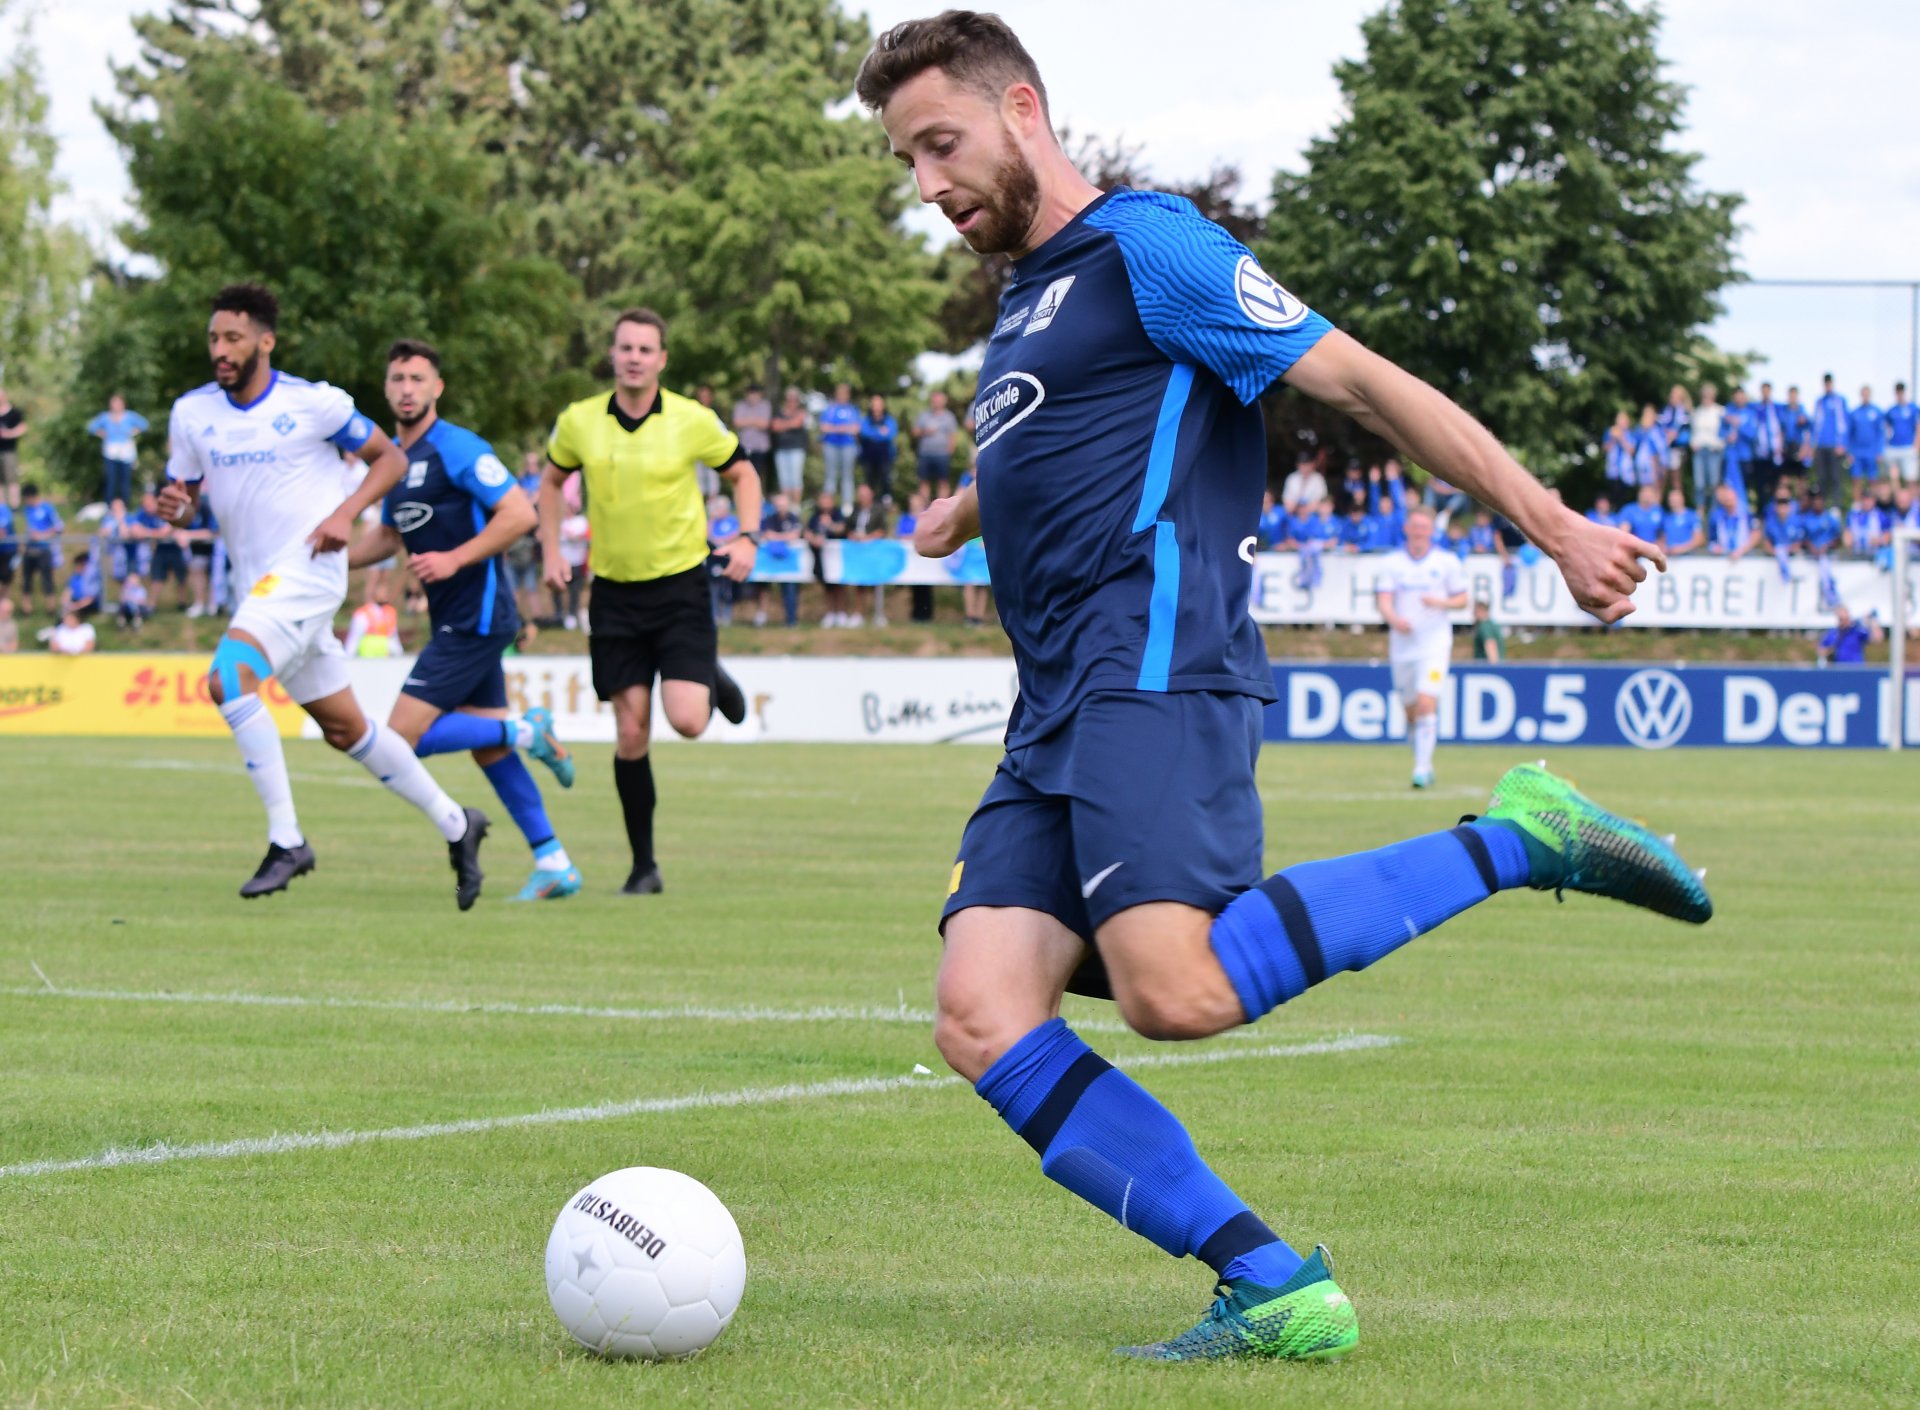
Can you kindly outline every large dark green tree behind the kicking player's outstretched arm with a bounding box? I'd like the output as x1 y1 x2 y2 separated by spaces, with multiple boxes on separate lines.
1260 0 1741 480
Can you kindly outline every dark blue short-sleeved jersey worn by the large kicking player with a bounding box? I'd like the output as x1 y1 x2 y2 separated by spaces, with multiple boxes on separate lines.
973 188 1338 747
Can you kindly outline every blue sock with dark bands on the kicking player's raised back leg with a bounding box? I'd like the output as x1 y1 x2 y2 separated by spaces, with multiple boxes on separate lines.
1212 822 1530 1022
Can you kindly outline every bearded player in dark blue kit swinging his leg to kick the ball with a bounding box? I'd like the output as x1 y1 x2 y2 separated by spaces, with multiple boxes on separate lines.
856 12 1711 1360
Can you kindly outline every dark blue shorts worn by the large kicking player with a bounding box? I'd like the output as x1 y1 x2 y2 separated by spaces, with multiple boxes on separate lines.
941 692 1263 999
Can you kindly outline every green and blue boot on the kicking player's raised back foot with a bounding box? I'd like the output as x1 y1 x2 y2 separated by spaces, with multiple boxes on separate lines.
1484 765 1713 926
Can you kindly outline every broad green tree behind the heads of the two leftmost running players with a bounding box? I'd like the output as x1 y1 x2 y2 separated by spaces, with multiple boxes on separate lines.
69 54 576 472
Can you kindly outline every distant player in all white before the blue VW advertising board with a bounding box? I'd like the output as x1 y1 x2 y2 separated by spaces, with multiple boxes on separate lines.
1375 505 1467 788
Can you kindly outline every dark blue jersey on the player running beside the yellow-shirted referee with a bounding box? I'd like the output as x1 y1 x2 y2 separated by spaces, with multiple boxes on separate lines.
380 421 520 636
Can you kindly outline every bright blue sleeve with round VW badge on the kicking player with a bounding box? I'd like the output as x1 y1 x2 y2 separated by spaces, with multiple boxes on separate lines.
1089 190 1332 405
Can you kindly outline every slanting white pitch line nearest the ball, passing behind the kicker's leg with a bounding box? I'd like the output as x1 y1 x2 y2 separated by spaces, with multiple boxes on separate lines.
0 1033 1400 1179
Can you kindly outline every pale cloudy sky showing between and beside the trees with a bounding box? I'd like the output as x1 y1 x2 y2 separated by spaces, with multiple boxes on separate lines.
15 0 1920 401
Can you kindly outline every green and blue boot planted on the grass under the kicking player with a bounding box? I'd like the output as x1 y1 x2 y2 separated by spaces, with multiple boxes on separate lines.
1119 1247 1359 1362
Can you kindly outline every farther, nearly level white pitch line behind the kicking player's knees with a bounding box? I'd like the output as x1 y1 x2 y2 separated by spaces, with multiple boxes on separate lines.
0 991 1159 1041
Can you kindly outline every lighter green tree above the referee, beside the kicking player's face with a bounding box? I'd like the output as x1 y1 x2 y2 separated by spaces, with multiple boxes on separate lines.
618 63 939 396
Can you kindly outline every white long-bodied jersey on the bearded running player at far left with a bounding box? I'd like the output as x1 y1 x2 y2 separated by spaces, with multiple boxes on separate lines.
167 371 374 597
